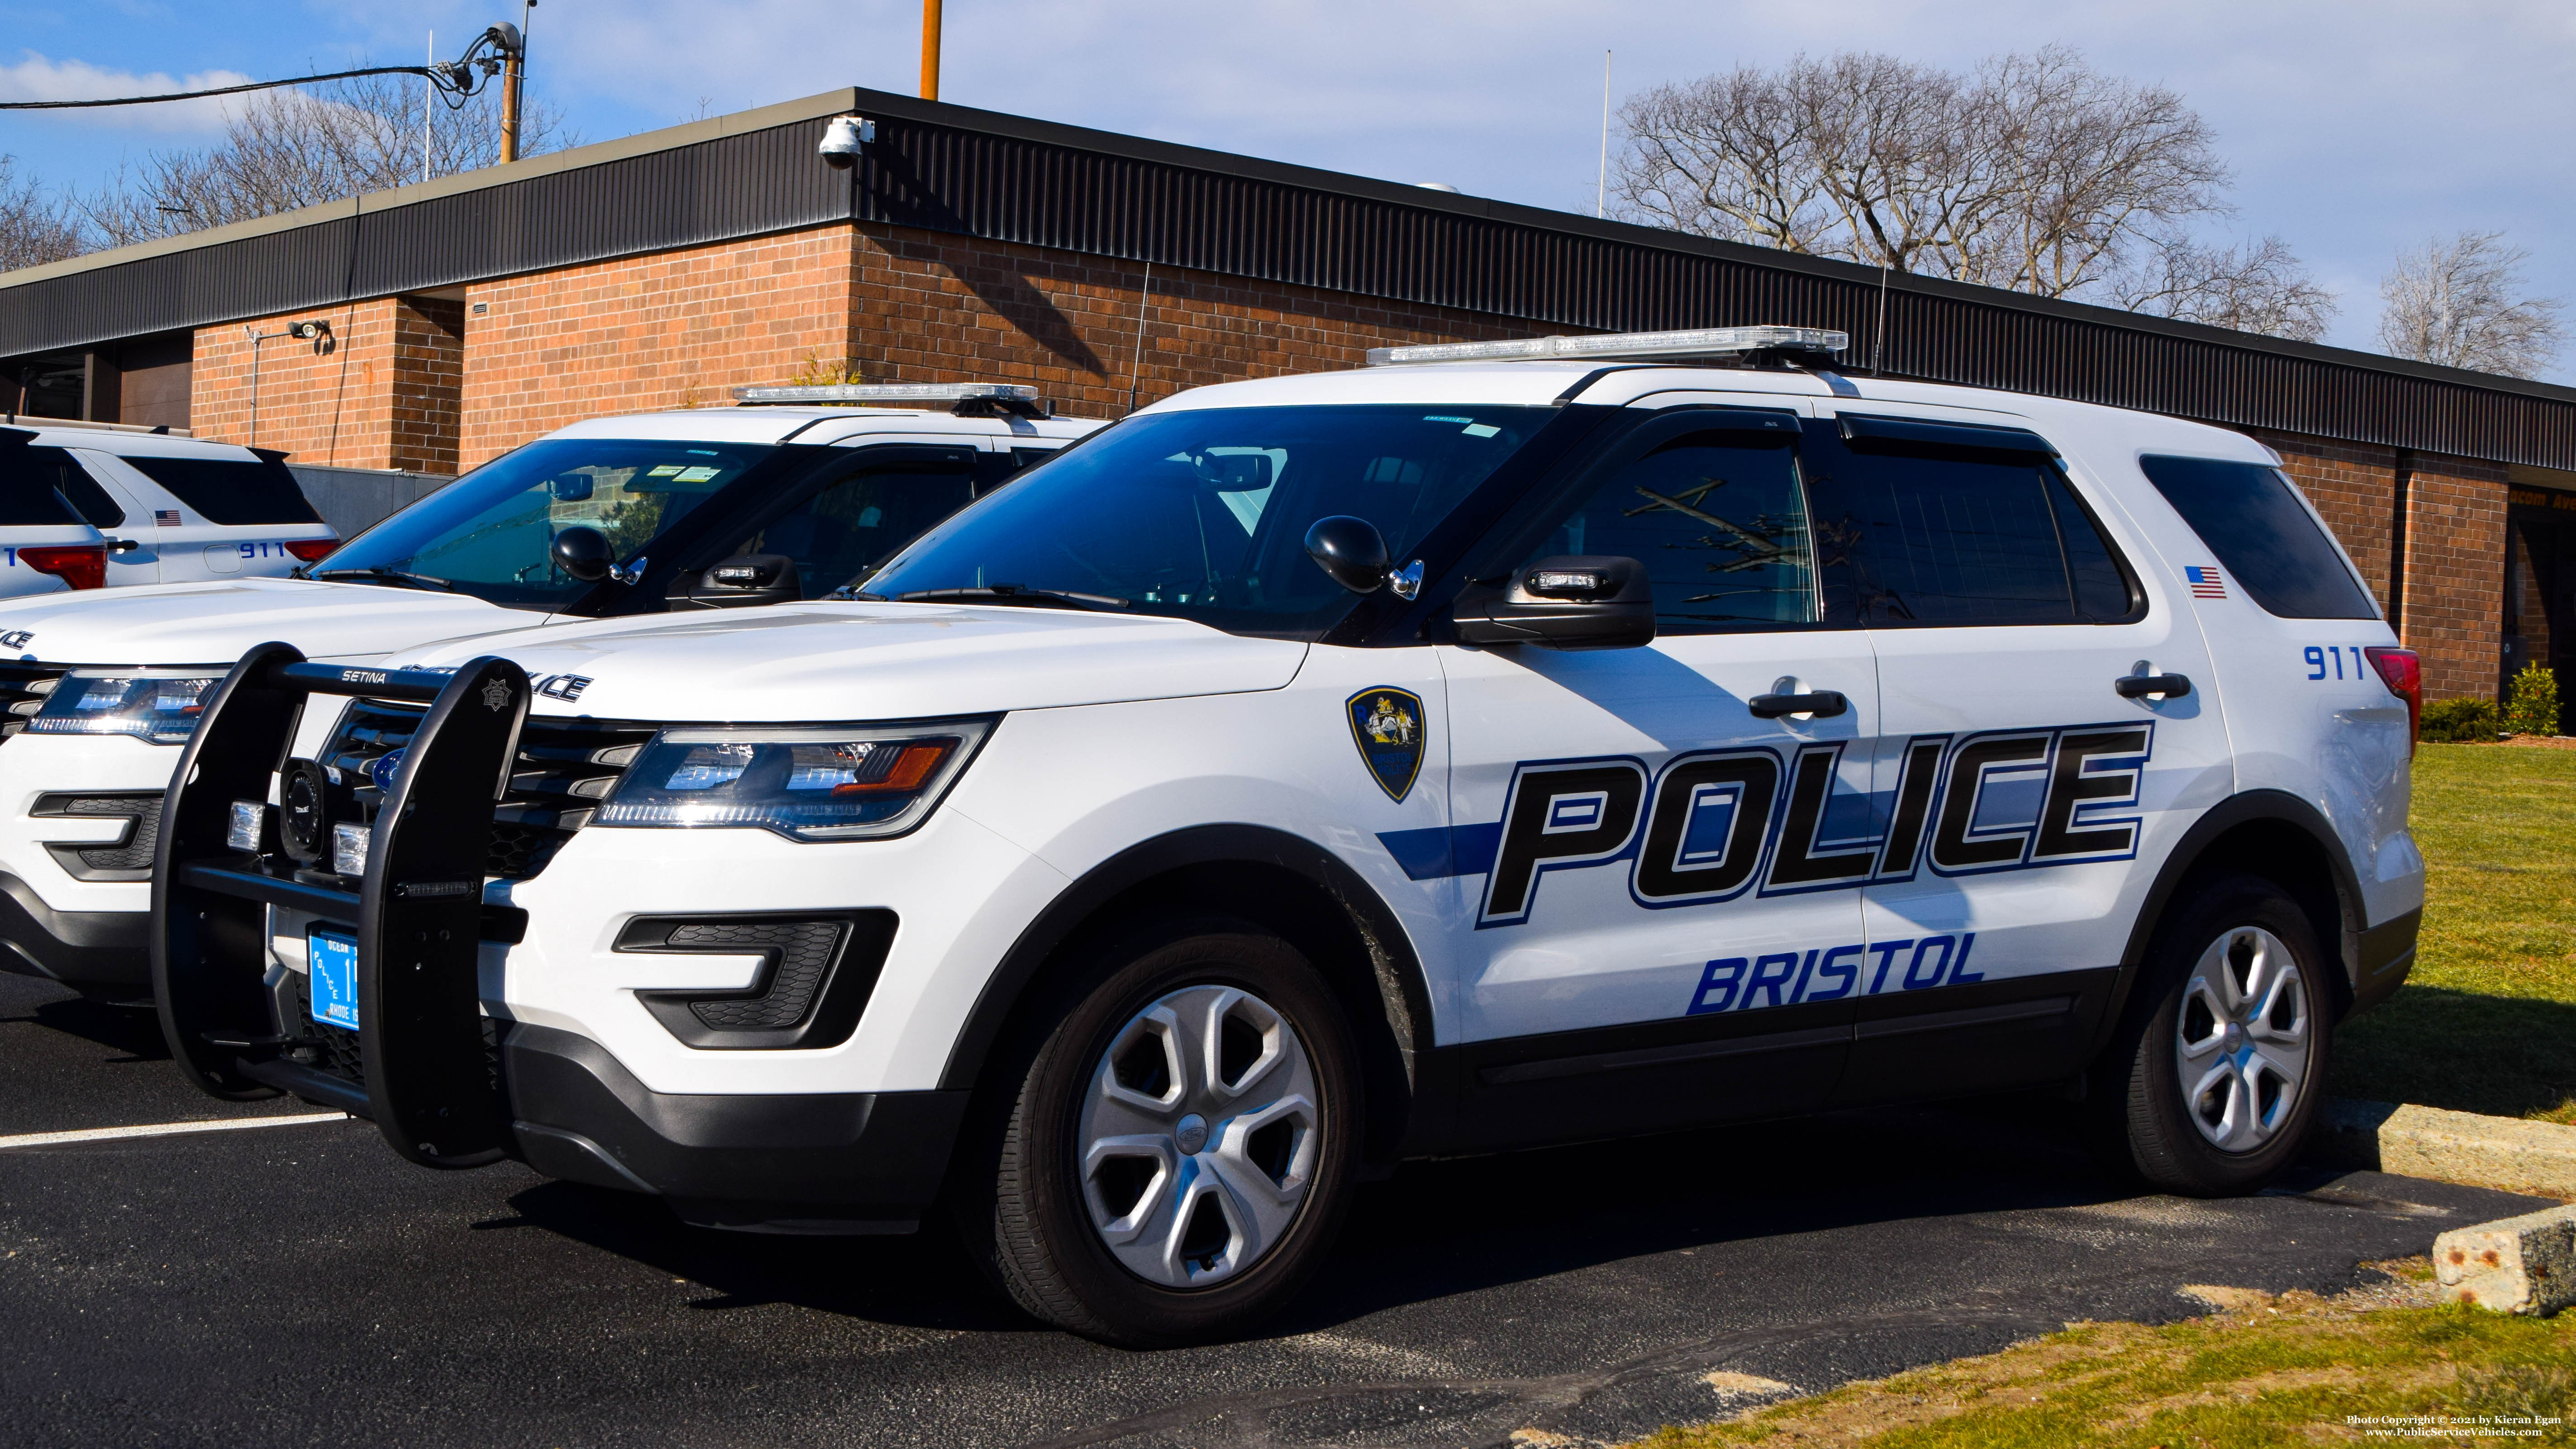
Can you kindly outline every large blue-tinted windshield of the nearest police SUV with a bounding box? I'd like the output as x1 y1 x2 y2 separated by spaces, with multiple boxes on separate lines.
858 404 1556 636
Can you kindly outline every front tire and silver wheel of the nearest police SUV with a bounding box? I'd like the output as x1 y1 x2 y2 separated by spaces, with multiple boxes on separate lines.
961 916 1360 1349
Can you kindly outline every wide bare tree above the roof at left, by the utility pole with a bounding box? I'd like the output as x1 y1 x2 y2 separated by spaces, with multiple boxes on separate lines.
80 75 572 247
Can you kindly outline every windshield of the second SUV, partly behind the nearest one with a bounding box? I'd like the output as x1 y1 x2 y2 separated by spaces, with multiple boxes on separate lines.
312 437 775 610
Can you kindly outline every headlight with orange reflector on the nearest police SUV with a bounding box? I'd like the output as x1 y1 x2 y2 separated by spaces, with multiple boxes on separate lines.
593 721 992 839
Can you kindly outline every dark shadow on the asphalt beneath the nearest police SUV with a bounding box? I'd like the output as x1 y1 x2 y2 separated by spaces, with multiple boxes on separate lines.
492 1097 2135 1338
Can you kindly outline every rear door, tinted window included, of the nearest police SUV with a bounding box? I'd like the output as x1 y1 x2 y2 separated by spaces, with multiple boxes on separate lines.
1808 404 2231 1102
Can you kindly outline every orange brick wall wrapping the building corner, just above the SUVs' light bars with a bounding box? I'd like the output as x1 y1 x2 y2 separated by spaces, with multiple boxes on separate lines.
459 224 1535 468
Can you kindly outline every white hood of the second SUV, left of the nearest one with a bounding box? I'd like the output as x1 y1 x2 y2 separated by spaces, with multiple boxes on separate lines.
0 579 546 664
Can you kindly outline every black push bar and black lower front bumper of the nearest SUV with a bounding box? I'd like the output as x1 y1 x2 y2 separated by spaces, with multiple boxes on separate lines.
152 643 966 1233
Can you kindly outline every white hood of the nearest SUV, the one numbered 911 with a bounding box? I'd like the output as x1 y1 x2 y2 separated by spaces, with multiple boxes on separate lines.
386 602 1306 723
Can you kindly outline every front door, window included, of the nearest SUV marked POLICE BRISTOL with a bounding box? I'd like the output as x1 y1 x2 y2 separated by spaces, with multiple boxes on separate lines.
1443 407 1878 1143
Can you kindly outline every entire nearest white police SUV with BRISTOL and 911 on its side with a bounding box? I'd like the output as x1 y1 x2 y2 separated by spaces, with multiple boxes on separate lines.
157 329 2424 1344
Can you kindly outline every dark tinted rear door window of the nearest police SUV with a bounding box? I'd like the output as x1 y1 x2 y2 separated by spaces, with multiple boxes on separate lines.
1808 427 2135 628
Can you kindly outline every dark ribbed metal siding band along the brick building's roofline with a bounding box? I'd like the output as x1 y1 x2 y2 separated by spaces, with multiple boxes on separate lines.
0 93 2576 468
